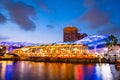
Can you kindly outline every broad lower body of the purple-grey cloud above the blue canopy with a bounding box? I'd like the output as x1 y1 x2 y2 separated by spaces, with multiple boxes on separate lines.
80 8 109 29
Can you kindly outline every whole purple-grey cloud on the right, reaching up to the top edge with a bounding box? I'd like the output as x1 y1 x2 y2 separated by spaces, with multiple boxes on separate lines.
77 0 111 29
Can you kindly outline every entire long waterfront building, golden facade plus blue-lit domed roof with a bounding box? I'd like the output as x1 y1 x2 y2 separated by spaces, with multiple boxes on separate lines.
8 35 113 58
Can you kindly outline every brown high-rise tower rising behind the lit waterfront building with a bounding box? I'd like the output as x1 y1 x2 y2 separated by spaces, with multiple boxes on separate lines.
63 26 87 42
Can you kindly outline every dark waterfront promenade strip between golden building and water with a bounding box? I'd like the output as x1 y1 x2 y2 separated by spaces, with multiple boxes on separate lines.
0 54 116 63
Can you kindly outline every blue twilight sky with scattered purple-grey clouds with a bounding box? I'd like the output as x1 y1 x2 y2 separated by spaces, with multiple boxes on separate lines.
0 0 120 43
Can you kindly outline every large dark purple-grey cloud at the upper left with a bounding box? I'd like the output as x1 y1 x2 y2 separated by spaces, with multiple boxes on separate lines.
1 0 36 31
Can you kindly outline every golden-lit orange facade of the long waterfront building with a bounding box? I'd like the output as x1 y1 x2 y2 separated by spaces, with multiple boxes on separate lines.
11 44 88 57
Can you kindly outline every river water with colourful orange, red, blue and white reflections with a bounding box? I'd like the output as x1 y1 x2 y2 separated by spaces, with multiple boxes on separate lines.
0 61 120 80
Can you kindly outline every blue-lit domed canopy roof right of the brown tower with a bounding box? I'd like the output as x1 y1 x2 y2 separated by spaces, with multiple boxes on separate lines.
74 35 108 49
